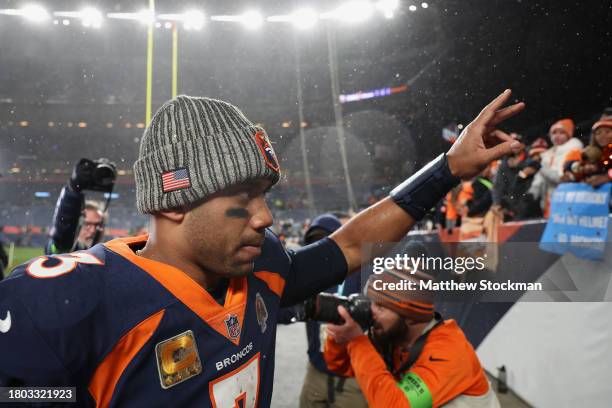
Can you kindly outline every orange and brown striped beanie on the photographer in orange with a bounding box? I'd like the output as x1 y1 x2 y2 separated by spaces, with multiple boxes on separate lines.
364 269 434 322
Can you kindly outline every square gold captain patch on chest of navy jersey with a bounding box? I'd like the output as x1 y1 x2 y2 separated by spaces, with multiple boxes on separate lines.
155 330 202 389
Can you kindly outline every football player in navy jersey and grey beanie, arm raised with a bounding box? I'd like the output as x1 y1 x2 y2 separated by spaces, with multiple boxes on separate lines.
0 90 524 408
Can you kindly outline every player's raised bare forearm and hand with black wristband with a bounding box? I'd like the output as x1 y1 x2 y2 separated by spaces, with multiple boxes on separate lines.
331 89 525 273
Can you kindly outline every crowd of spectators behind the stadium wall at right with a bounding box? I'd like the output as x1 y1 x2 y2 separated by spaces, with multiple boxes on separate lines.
434 109 612 239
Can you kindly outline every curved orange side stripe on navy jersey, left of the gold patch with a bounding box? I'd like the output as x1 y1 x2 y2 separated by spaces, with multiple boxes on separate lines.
89 309 165 407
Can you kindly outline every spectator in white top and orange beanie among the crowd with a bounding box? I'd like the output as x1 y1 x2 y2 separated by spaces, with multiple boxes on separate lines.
529 119 583 217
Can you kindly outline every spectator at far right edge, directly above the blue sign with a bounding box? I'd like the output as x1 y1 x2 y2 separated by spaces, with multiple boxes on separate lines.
564 113 612 187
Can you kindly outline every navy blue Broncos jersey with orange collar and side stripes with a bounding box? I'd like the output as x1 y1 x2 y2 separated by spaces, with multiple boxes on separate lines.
0 232 346 408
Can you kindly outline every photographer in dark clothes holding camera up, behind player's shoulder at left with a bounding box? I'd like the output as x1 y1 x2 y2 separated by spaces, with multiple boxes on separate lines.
45 159 117 255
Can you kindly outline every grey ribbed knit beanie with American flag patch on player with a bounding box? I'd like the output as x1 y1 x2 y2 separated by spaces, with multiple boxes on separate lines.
134 95 280 214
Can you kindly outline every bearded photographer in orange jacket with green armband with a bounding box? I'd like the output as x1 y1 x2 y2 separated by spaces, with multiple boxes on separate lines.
324 270 500 408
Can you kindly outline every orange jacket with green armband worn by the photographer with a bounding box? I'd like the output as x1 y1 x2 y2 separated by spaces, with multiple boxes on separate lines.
324 320 490 408
